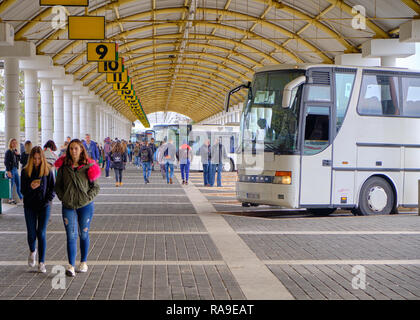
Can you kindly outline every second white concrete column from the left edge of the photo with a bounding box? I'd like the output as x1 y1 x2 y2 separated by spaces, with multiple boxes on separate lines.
24 69 39 146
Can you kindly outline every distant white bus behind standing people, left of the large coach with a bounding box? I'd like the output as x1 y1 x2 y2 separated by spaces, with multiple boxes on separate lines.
188 124 239 171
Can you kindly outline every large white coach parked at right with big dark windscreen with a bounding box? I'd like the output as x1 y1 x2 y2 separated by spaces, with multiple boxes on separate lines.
227 64 420 215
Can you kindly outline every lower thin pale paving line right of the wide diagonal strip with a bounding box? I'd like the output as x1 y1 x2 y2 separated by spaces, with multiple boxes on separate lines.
262 260 420 265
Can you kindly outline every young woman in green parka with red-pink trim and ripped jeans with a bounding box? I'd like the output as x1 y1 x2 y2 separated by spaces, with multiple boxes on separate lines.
54 139 101 277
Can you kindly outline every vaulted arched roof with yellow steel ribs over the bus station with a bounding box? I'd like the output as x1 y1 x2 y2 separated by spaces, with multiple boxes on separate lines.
0 0 420 121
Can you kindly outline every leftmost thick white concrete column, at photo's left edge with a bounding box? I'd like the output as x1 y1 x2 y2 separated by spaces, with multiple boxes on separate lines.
4 58 20 149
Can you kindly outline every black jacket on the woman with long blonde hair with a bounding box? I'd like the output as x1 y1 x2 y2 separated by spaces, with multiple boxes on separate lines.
20 168 55 208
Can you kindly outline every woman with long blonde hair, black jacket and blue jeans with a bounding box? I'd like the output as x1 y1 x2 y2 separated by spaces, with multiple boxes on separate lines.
21 146 55 273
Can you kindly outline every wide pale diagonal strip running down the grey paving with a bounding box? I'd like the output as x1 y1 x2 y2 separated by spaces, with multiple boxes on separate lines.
179 174 293 300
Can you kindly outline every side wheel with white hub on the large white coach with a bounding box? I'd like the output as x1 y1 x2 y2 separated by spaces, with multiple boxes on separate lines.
352 177 395 216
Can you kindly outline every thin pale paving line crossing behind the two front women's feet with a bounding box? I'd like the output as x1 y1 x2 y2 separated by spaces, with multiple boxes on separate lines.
0 260 225 268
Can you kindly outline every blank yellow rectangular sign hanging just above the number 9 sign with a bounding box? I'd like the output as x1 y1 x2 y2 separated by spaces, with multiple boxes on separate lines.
68 16 105 40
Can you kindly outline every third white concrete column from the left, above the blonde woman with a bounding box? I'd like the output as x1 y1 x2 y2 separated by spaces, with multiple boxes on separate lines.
40 79 53 146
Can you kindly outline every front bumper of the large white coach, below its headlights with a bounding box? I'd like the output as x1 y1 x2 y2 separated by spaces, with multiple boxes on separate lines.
236 182 299 209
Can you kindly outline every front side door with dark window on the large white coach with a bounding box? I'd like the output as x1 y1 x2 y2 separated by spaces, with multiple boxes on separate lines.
299 72 334 207
